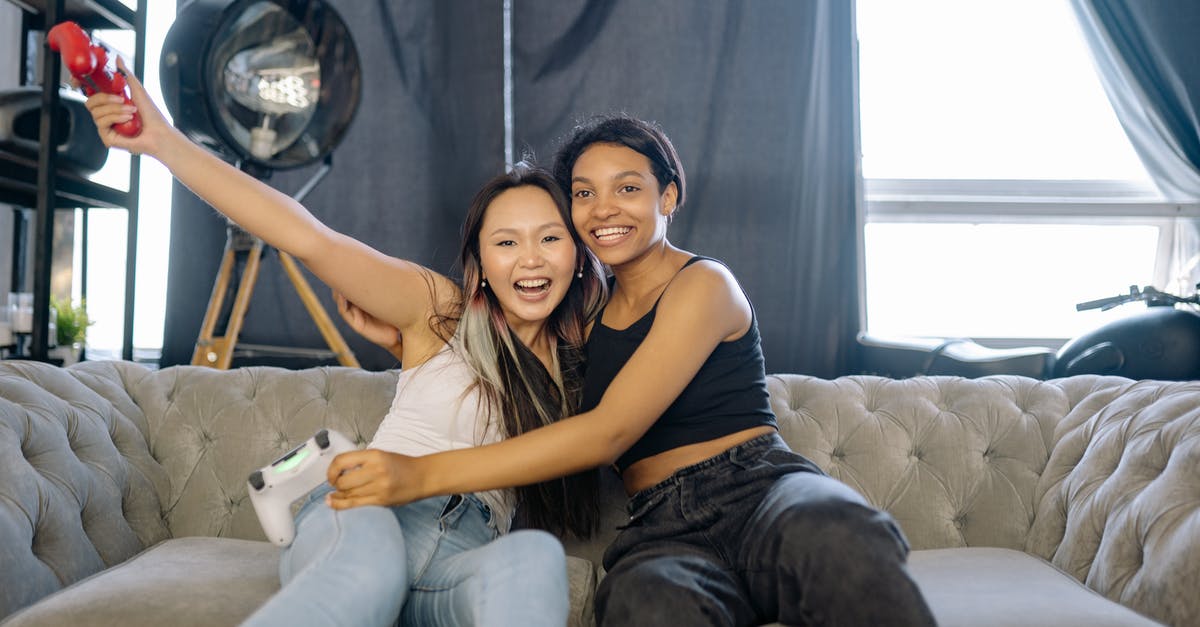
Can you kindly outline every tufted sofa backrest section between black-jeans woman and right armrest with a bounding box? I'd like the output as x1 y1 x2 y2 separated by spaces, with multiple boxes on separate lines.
769 375 1070 550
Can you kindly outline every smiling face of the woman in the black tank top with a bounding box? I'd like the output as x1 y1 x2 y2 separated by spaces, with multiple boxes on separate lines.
571 143 676 267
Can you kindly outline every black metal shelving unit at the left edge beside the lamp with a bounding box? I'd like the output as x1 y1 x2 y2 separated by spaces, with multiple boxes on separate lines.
0 0 148 360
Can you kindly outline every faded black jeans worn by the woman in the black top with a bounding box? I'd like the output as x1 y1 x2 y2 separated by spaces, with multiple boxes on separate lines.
595 434 934 626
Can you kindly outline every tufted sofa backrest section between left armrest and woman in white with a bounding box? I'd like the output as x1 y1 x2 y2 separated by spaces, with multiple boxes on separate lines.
121 366 396 539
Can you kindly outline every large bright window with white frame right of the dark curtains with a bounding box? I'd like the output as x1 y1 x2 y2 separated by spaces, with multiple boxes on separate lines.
857 0 1194 346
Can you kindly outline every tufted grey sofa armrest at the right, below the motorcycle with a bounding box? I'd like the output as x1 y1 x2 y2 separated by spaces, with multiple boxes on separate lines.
1026 375 1200 625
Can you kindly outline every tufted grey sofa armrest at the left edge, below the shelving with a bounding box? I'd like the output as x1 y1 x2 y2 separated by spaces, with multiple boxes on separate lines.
0 360 168 619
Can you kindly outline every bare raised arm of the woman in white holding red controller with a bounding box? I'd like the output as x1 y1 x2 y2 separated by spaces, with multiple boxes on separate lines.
88 60 457 330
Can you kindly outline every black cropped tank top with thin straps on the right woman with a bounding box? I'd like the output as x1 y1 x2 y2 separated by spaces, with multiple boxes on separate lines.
582 256 775 472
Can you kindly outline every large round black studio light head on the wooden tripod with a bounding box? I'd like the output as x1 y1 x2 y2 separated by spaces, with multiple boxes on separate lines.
161 0 361 172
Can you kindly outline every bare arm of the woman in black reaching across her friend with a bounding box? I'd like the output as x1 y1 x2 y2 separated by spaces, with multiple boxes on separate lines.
329 258 750 508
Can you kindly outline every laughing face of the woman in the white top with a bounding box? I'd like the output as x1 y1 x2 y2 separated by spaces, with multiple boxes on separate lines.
479 185 578 333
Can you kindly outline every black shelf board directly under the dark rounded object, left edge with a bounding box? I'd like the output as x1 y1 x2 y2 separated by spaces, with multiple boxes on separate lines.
0 151 131 209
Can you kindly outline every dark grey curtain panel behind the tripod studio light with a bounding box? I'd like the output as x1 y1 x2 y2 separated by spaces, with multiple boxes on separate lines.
161 0 504 370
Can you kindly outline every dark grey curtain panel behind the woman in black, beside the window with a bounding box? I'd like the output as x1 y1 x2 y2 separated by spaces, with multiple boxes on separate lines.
512 0 859 377
